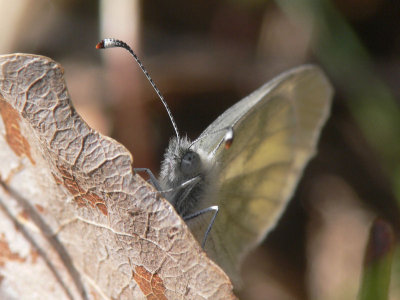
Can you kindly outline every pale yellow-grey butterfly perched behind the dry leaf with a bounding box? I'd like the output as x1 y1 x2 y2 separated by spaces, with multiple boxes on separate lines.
98 39 333 282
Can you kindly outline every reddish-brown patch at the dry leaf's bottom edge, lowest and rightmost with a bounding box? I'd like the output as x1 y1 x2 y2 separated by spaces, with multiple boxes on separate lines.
133 266 167 300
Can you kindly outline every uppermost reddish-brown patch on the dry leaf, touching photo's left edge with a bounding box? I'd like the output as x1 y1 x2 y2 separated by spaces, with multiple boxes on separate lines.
0 96 35 165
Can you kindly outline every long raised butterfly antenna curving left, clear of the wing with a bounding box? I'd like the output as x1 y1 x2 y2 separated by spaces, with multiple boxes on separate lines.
96 38 180 143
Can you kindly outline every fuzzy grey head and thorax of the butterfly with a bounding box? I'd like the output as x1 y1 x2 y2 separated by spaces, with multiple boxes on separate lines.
159 138 213 217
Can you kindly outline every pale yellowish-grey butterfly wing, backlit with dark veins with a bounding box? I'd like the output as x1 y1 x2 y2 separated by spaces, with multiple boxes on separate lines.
195 66 333 281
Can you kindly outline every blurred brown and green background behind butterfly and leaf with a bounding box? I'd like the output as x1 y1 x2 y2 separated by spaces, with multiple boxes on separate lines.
0 0 400 300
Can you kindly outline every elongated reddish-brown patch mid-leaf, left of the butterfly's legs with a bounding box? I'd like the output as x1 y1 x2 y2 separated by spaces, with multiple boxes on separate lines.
54 166 108 216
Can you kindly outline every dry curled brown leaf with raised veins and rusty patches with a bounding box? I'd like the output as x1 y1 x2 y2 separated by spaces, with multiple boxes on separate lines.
0 54 234 299
